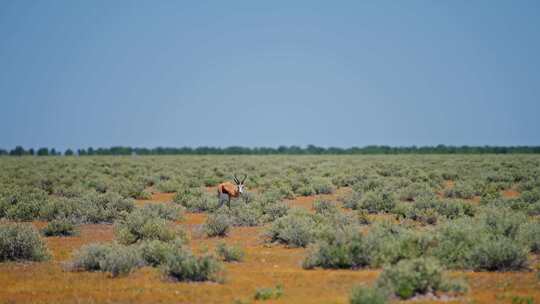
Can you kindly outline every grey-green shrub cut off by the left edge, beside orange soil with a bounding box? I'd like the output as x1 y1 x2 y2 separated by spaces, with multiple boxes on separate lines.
0 223 50 262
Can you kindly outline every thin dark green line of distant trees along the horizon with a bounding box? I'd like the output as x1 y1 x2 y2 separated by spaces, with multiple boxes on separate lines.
0 145 540 156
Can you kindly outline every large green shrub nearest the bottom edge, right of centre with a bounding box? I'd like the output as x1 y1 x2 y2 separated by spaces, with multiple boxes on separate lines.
376 258 443 299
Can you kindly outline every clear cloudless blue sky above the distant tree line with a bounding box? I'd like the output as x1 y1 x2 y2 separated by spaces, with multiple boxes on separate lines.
0 0 540 149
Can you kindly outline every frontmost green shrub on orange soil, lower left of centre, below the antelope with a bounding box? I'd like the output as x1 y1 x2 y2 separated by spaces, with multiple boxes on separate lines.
163 249 222 281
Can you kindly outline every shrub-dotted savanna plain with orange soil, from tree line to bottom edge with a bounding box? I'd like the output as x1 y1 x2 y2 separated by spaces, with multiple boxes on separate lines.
0 154 540 304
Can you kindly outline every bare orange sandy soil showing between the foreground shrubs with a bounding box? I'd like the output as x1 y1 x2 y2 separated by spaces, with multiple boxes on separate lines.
0 189 540 303
